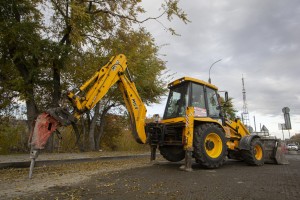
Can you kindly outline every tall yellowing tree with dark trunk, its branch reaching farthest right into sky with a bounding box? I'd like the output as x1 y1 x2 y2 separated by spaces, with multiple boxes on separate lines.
50 0 188 106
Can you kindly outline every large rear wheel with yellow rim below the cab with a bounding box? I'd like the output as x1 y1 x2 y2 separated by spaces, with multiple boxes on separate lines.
193 123 227 169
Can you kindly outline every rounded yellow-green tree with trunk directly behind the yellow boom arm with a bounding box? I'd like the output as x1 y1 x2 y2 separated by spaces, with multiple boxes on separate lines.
67 28 166 150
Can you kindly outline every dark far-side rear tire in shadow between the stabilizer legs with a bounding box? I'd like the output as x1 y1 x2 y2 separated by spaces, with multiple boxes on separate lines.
159 146 185 162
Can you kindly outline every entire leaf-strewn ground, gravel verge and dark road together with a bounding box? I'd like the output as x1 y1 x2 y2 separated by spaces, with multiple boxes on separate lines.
0 152 300 200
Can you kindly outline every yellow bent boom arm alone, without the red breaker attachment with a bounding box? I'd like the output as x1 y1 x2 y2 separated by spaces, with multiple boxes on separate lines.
68 54 147 144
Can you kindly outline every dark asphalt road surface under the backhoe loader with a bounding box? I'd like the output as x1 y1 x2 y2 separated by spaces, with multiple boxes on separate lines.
21 154 300 200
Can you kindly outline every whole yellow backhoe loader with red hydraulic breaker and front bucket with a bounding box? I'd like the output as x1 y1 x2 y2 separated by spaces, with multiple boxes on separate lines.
29 54 286 178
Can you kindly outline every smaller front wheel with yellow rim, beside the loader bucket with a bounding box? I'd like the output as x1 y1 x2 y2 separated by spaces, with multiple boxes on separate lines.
242 138 265 166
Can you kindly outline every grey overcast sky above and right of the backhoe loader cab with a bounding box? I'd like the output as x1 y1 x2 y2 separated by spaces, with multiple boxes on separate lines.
141 0 300 137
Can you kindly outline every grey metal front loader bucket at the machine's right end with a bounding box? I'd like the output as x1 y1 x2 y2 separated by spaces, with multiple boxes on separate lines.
261 138 289 165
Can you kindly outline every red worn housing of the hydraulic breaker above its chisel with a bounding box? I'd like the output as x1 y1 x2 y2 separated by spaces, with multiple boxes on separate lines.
30 112 60 149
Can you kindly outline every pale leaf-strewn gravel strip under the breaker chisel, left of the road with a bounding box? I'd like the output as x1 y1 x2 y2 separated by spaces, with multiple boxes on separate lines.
0 155 149 199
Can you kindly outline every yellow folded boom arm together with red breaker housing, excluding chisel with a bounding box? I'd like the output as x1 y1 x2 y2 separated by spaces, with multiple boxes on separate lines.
30 54 147 152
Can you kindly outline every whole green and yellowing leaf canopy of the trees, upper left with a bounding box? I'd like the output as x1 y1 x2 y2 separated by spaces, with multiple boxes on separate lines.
0 0 188 110
